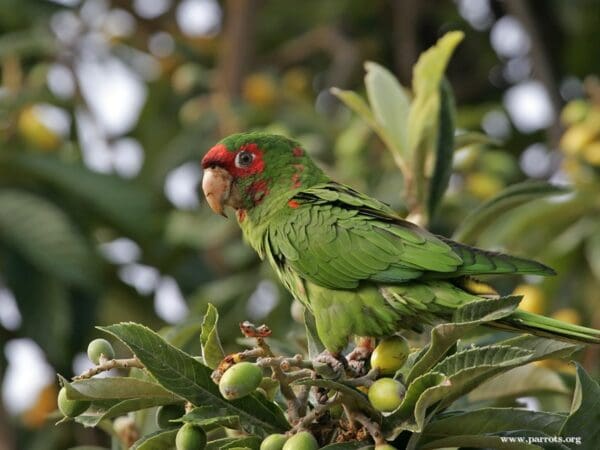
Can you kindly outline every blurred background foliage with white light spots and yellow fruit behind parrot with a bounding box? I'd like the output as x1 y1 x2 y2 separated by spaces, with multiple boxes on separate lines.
0 0 600 450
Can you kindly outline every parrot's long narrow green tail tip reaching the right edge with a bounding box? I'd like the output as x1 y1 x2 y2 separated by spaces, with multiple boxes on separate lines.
493 310 600 344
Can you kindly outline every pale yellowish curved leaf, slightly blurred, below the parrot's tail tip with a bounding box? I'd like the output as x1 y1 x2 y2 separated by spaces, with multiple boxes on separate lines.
468 364 570 402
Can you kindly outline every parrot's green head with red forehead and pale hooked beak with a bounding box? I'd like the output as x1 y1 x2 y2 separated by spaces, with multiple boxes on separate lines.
202 132 325 215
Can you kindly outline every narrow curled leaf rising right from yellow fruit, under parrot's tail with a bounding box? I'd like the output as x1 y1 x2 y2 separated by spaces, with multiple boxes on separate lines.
406 297 520 383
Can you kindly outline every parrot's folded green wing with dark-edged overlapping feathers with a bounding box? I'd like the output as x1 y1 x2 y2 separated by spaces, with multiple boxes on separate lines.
266 183 462 289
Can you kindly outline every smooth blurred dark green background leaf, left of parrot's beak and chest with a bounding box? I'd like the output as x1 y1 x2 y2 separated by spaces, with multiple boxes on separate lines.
1 153 158 237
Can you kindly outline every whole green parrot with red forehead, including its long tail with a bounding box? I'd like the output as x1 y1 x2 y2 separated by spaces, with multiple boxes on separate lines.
202 132 600 355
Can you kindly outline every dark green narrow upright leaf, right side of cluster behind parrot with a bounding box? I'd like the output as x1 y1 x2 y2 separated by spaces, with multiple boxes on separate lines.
427 79 455 218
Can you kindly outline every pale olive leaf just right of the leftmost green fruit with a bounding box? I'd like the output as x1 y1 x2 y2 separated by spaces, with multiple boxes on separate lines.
59 375 181 402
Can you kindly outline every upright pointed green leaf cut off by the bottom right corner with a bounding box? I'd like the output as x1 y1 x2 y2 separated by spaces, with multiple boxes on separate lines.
560 363 600 450
